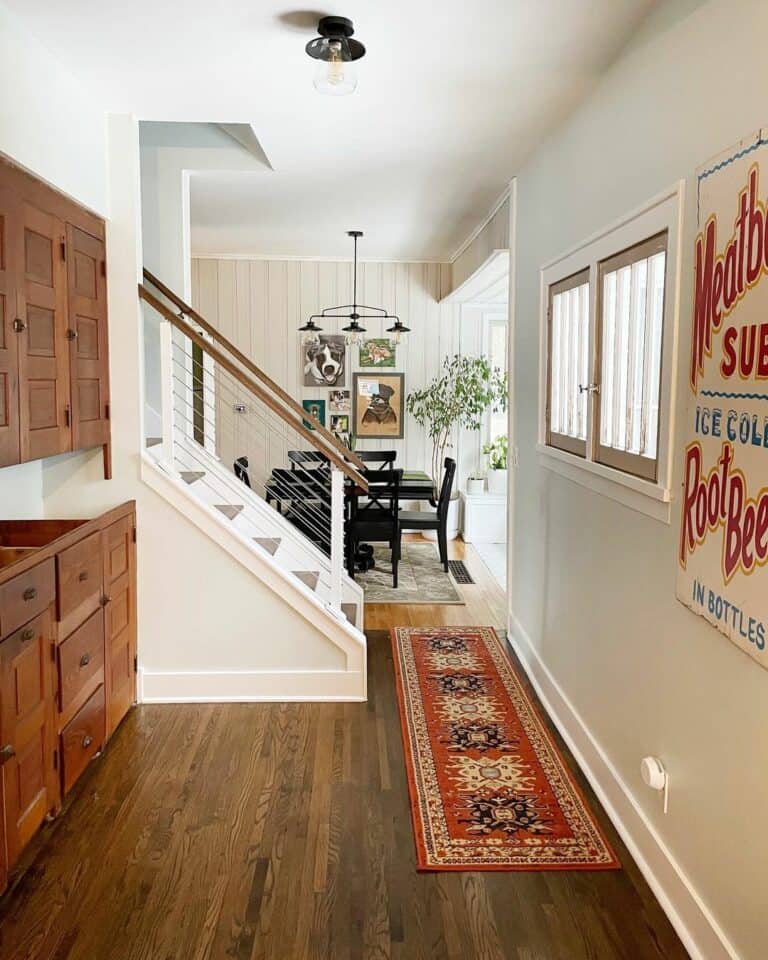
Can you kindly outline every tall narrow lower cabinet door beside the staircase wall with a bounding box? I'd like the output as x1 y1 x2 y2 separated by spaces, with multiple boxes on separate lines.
102 517 136 736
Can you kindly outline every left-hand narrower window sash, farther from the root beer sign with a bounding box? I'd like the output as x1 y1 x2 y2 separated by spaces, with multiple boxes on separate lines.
547 270 590 457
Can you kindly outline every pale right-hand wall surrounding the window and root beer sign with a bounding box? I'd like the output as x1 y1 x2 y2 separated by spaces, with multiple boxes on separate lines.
511 0 768 960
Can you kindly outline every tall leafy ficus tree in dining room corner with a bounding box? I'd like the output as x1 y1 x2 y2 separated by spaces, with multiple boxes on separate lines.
406 354 507 539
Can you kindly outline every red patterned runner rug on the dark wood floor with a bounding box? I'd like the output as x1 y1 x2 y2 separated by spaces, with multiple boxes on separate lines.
392 627 619 870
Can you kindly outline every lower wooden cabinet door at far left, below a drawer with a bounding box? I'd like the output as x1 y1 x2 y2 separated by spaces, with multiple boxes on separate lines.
0 611 57 865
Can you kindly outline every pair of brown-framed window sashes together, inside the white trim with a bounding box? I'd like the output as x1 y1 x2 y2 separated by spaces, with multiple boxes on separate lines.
546 231 667 481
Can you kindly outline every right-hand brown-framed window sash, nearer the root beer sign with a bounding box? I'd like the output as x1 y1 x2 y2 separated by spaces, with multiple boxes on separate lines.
595 233 667 480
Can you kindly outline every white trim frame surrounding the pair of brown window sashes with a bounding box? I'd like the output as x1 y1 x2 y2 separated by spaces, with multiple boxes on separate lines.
536 180 685 524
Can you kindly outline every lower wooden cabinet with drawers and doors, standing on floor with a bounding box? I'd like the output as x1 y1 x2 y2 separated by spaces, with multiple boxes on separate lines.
0 503 136 892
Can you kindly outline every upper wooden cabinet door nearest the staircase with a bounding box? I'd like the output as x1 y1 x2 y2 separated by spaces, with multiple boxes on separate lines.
67 224 109 450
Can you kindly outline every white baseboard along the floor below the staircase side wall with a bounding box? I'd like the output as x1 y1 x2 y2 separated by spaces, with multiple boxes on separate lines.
139 668 365 703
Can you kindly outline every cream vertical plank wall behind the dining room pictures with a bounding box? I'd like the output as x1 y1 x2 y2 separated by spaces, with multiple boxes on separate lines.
192 258 483 489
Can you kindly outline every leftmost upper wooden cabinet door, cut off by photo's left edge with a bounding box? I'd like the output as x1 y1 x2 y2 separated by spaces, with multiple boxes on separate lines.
0 187 20 467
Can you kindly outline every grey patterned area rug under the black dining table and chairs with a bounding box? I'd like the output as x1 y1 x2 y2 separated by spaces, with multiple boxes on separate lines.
355 541 464 604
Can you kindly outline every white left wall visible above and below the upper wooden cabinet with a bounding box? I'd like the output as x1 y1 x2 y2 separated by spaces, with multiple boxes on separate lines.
0 6 107 519
